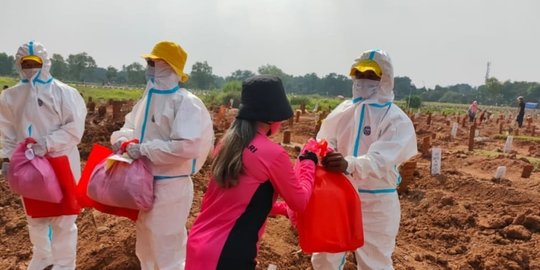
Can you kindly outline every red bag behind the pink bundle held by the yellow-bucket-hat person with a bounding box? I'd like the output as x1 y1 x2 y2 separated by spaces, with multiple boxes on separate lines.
77 144 139 221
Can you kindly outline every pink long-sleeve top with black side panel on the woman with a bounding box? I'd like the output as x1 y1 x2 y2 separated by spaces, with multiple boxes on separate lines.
186 131 315 270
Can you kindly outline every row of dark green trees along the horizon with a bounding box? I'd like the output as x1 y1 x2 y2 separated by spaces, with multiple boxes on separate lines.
0 52 540 105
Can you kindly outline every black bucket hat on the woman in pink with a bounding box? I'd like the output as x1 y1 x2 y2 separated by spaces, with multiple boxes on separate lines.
236 75 293 122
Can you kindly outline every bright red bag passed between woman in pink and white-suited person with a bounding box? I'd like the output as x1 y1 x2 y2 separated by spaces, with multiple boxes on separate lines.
297 139 364 253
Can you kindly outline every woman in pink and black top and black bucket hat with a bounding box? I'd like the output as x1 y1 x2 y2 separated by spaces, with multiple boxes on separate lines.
186 75 317 270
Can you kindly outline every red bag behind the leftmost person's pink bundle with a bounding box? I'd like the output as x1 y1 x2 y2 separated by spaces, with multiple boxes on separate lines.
23 156 81 218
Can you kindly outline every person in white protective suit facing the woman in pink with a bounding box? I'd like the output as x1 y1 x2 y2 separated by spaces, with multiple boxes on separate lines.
311 50 417 270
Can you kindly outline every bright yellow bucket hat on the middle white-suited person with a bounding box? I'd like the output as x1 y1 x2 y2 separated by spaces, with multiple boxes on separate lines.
142 41 189 82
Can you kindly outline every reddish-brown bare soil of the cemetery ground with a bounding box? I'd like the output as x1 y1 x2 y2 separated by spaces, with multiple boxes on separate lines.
0 99 540 270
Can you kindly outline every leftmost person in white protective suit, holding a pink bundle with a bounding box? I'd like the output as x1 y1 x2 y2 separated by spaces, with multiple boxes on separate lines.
0 41 86 270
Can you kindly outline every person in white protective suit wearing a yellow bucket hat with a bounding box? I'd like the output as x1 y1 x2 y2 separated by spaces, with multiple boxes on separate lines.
111 41 214 270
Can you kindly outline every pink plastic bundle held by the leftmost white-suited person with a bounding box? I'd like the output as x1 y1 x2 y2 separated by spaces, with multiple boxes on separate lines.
7 138 63 203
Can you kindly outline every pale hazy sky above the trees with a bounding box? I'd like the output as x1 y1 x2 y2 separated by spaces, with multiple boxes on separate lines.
0 0 540 87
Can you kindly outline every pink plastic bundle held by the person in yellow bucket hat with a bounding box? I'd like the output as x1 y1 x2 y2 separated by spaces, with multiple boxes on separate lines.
87 155 154 211
